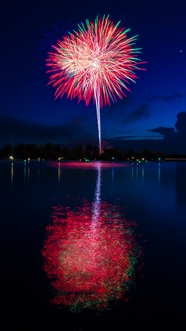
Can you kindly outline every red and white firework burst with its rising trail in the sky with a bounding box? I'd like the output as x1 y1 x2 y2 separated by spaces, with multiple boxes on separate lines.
46 16 144 154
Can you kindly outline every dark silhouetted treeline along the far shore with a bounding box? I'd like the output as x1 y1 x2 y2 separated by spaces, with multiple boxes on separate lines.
0 142 186 161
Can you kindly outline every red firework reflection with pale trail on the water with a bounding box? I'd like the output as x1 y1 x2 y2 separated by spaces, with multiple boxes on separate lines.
42 167 140 312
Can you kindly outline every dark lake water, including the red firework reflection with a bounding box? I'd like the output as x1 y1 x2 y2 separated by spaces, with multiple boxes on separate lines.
0 162 186 331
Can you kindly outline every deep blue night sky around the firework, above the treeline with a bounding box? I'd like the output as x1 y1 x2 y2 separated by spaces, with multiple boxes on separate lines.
0 0 186 154
